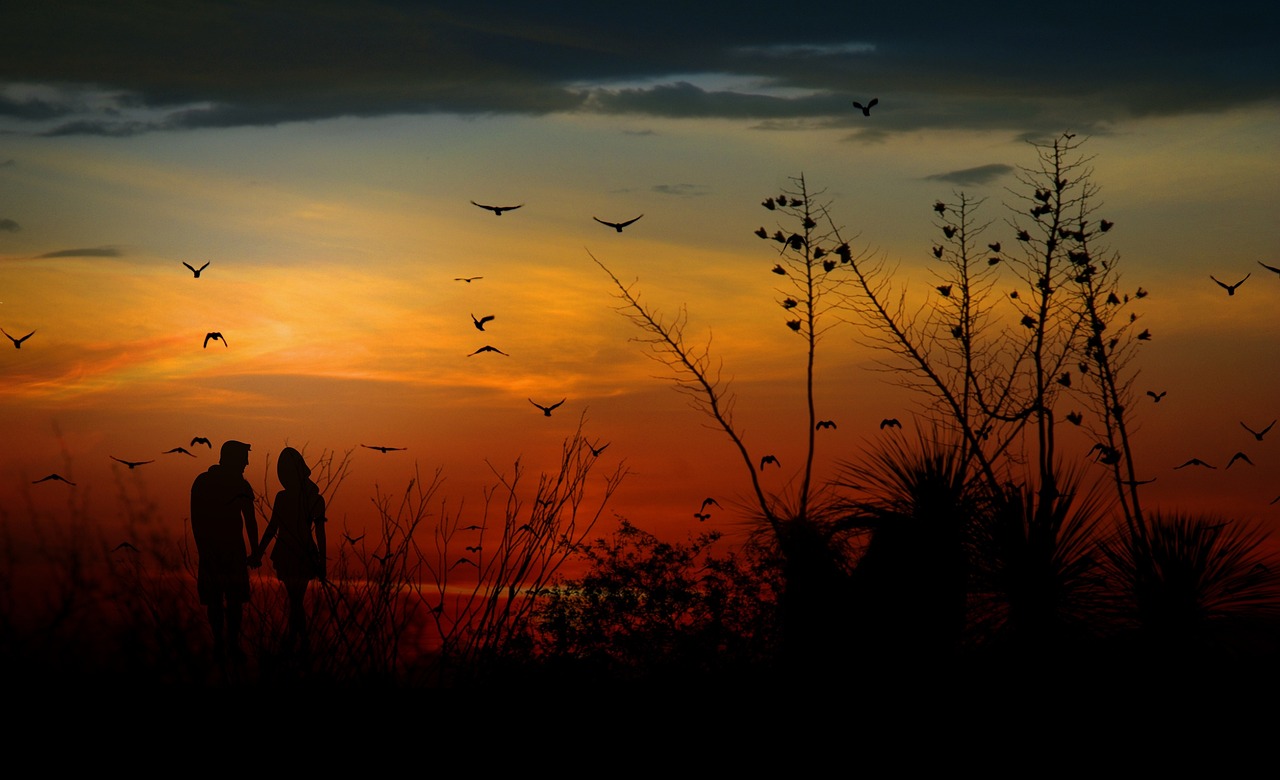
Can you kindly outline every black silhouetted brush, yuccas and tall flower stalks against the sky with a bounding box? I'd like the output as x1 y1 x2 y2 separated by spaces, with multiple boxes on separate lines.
0 133 1280 688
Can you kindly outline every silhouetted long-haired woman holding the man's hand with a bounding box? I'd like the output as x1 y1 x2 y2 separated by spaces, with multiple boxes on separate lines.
253 447 326 649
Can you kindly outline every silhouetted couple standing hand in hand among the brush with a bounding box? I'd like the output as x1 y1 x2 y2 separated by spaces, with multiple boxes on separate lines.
191 441 326 661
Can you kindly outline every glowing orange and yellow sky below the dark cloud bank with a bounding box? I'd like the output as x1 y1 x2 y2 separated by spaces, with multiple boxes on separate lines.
0 4 1280 571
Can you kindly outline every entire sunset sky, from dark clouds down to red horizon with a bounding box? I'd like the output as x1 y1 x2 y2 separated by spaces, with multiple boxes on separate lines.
0 0 1280 555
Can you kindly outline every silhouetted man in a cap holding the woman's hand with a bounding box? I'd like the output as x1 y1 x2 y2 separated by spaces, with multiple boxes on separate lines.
191 441 257 661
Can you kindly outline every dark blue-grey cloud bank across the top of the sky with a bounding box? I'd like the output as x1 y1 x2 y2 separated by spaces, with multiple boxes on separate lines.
0 0 1280 140
